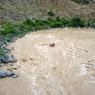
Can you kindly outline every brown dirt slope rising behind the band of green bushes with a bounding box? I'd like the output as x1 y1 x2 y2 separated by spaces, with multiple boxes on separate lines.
0 0 95 21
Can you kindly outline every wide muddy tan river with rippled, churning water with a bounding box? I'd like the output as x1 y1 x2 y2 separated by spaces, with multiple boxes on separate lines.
0 28 95 95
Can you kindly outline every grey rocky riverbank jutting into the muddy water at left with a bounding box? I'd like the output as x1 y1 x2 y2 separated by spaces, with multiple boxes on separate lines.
0 39 17 78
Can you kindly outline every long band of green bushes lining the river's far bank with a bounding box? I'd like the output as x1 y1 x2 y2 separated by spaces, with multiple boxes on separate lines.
0 17 95 58
